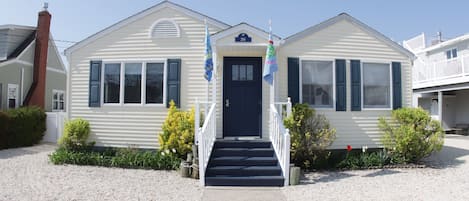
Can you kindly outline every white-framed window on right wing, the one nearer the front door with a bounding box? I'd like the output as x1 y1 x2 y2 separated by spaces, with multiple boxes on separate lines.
300 60 335 109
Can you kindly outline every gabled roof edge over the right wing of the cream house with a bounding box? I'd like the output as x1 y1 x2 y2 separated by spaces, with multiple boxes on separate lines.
284 13 415 59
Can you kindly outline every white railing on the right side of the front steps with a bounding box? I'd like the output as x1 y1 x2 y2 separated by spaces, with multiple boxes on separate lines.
270 98 291 186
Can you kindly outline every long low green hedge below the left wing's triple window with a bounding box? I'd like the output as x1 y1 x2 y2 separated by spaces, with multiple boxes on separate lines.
49 148 181 170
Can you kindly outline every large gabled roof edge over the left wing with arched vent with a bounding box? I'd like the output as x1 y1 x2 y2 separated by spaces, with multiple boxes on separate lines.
65 0 230 57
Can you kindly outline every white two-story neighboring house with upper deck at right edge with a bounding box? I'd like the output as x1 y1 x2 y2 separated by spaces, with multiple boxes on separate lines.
404 34 469 132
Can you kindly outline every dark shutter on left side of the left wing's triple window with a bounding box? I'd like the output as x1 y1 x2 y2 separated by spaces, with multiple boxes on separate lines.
88 61 103 107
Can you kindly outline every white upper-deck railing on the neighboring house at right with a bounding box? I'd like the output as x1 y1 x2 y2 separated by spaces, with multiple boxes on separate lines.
413 55 469 85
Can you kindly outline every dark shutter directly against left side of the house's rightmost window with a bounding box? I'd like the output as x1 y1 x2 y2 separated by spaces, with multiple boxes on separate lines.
350 60 362 111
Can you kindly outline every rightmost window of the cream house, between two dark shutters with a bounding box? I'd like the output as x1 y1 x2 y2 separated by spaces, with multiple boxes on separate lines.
361 62 392 109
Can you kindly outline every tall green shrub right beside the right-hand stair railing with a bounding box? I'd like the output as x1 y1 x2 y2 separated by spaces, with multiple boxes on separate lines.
284 104 335 169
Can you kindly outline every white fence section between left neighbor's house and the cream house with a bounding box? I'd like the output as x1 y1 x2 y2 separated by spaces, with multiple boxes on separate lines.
42 112 67 143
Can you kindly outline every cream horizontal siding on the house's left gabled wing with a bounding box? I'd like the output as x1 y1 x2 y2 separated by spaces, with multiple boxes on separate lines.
69 8 223 148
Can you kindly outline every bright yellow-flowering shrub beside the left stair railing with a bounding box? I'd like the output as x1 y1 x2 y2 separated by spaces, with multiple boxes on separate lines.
158 101 195 158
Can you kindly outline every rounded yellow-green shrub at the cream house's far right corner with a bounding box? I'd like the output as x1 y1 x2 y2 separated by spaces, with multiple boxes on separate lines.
379 108 444 162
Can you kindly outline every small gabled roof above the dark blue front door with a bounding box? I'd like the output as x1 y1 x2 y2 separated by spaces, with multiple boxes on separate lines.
211 22 281 45
